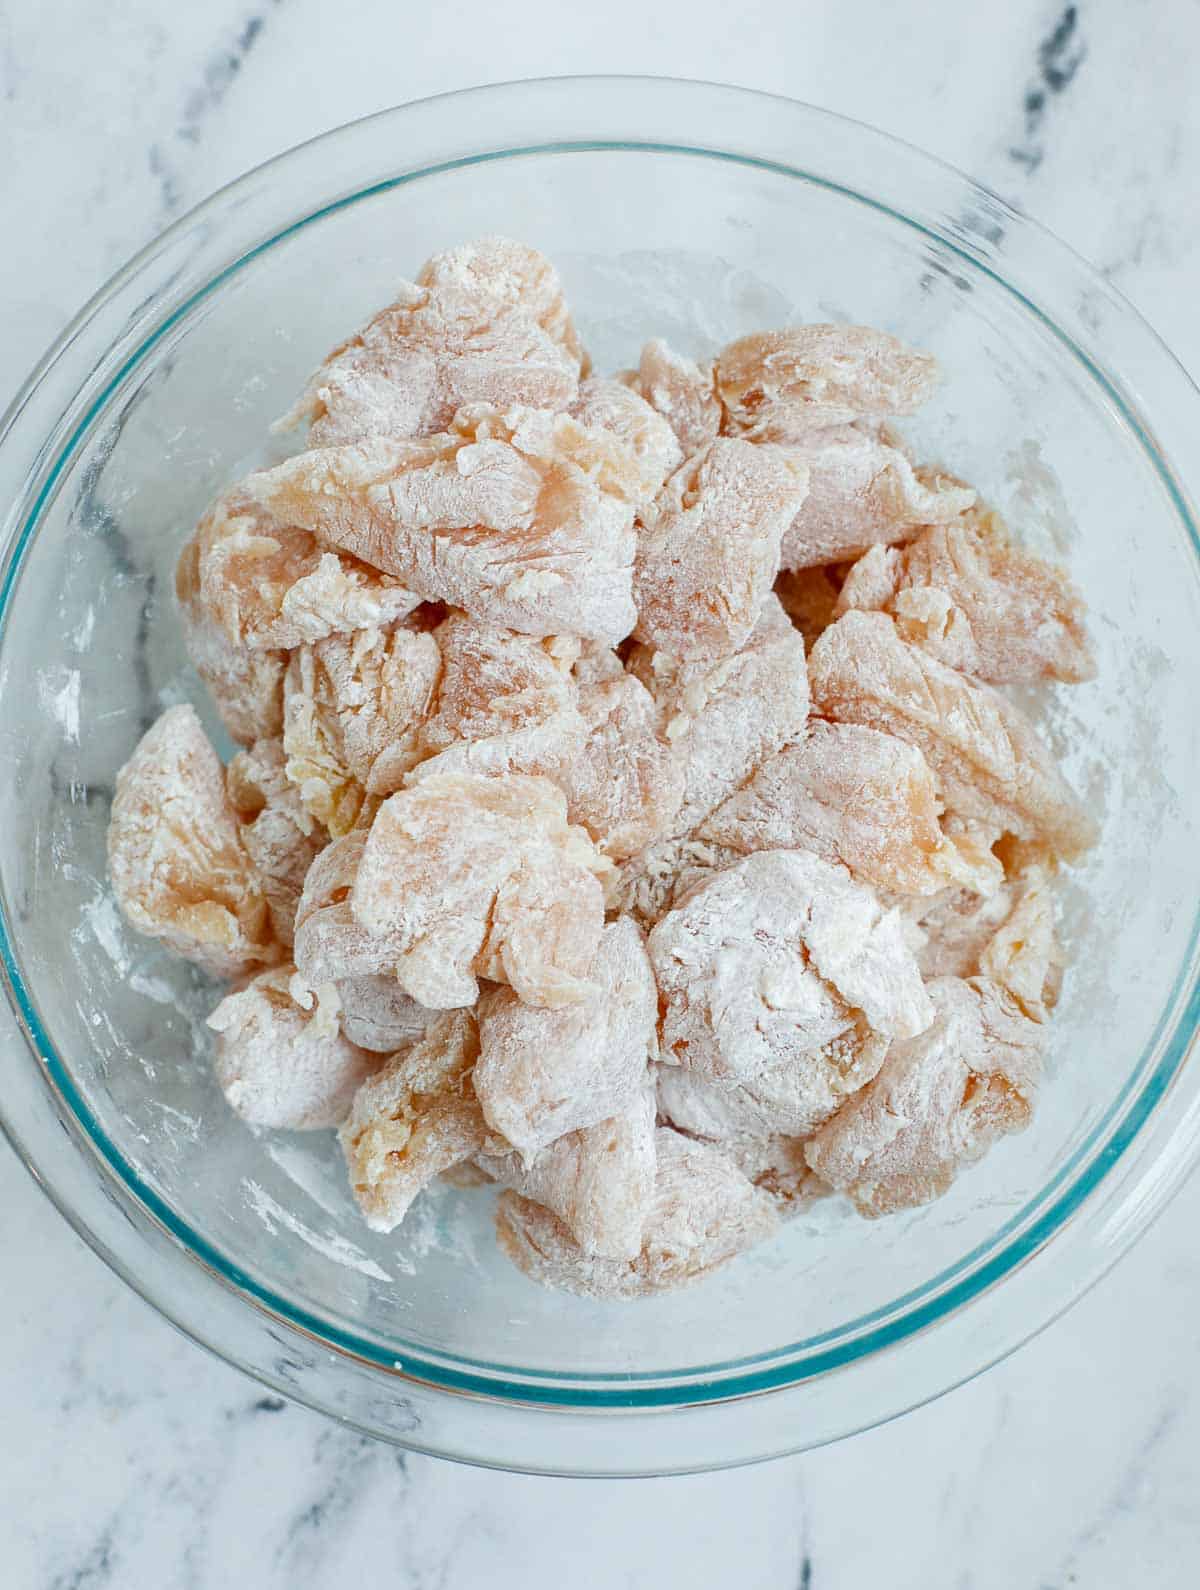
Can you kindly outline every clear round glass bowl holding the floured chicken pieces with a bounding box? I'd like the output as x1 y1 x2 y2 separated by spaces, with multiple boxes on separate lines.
0 78 1200 1474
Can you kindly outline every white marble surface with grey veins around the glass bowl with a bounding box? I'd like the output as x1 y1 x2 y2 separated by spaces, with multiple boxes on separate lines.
0 0 1200 1590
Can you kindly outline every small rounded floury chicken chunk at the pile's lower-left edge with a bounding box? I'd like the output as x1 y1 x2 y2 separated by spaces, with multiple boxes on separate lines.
208 965 378 1132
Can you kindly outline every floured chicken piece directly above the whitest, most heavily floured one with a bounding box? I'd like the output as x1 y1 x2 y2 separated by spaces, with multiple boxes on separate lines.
698 722 1003 895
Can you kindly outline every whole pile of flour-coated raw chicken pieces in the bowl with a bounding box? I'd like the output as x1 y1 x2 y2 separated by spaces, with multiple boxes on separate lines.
110 239 1094 1297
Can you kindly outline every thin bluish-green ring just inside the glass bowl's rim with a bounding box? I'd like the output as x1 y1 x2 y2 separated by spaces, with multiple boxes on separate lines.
0 140 1200 1407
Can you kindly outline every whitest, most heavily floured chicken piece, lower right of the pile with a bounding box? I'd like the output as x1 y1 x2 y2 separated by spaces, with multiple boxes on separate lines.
647 851 933 1083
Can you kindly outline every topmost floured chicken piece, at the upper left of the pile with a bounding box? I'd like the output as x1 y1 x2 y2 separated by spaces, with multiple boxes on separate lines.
278 237 582 447
